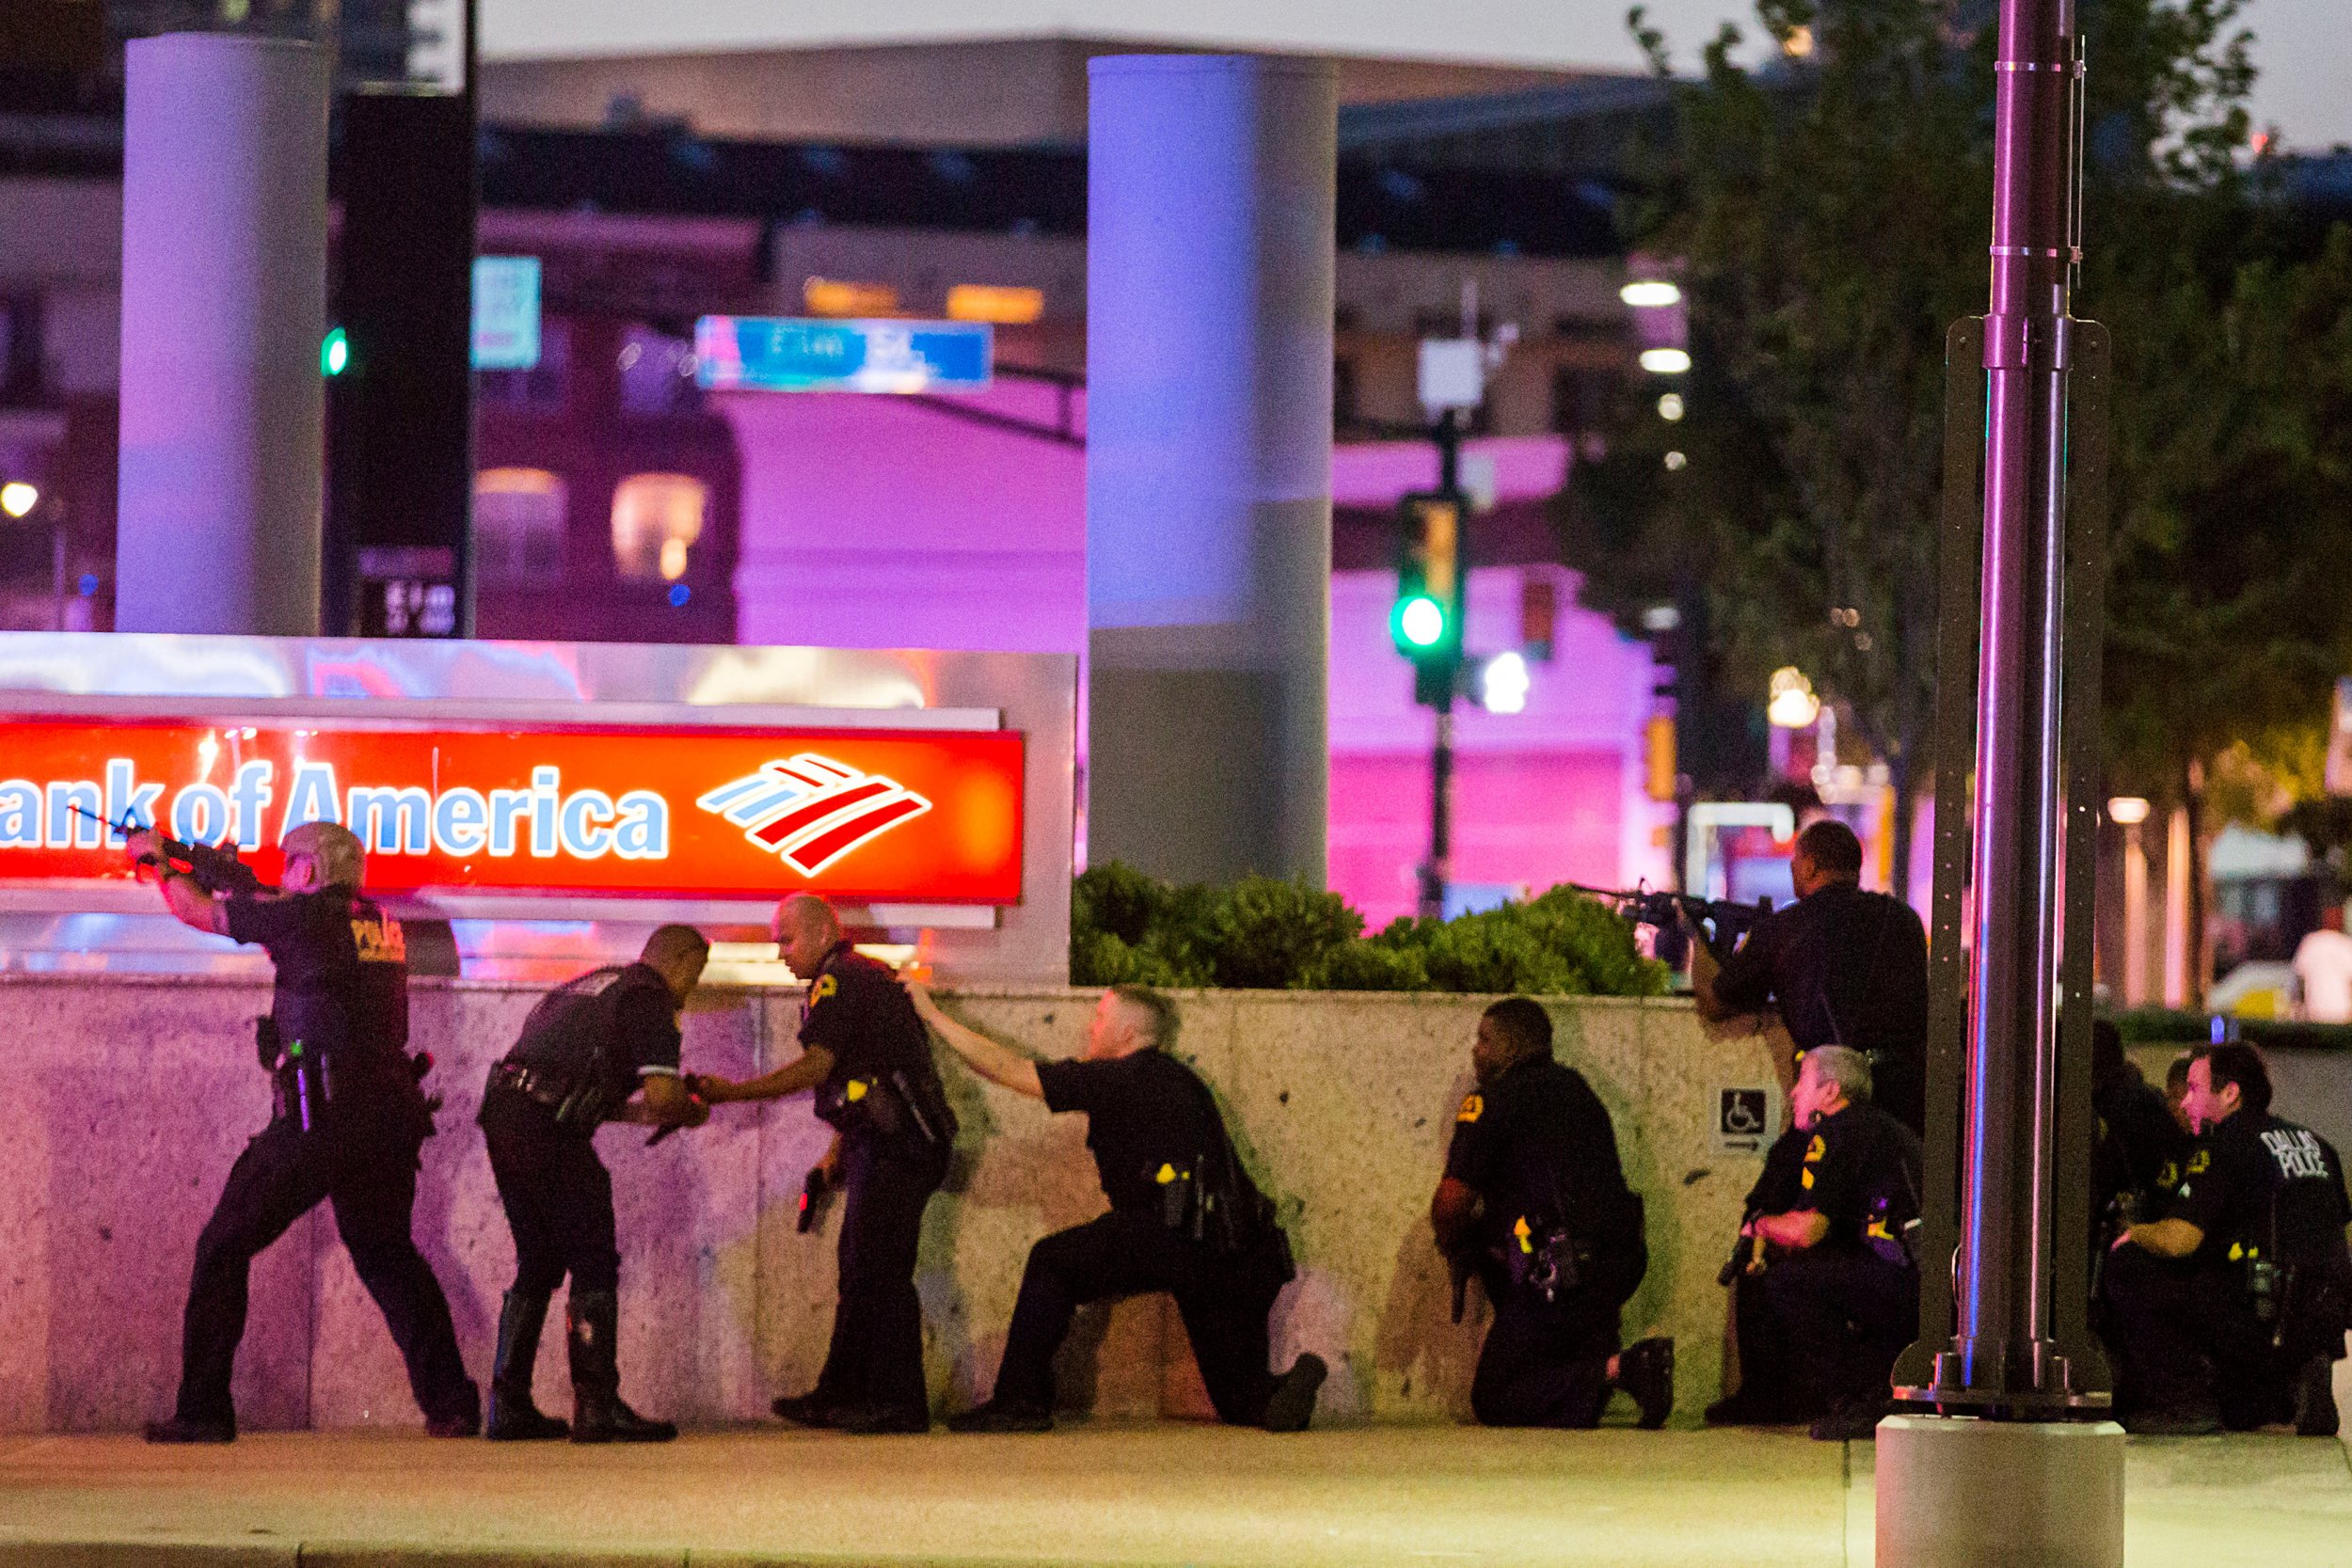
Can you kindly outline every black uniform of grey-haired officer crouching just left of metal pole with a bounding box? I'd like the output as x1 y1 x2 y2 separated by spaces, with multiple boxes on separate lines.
1736 1101 1919 1420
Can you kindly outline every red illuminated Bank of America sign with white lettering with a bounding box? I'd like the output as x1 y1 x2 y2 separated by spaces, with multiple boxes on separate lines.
0 715 1024 905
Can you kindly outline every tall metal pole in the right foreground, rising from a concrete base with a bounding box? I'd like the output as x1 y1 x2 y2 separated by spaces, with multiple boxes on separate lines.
1936 0 2079 1416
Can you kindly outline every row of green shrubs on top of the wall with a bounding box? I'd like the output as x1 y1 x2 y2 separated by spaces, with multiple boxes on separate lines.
1071 863 1665 997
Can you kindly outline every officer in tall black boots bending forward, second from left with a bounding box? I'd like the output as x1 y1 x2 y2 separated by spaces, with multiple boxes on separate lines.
480 927 710 1444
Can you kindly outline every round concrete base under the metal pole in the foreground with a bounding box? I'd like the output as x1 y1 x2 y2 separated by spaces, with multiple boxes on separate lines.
1877 1416 2124 1568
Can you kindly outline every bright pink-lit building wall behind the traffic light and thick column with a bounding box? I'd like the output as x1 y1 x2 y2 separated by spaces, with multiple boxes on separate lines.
718 392 1668 927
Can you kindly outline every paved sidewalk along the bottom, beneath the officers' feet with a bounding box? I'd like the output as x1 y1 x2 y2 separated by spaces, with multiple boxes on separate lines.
0 1425 2352 1568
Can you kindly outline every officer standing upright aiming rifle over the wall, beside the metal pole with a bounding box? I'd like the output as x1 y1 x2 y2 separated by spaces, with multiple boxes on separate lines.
1692 818 1927 1133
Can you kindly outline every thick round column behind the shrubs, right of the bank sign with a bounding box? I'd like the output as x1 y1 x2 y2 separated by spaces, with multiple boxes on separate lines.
1087 54 1339 886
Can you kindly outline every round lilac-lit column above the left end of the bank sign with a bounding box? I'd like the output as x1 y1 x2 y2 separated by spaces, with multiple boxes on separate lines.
116 33 329 637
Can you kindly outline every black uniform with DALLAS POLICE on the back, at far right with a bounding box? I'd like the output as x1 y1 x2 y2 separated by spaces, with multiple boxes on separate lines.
2106 1112 2352 1430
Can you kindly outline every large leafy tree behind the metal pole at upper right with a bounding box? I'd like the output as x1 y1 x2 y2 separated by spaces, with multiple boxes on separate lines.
1557 0 2343 930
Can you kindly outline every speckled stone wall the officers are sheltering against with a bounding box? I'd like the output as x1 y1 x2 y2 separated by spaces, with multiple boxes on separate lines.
0 975 1772 1432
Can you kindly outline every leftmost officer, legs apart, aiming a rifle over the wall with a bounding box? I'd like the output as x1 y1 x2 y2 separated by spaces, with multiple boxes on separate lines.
130 823 483 1444
